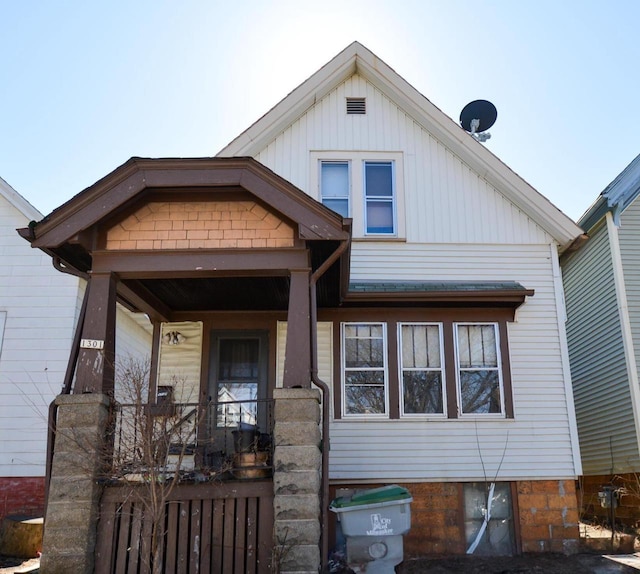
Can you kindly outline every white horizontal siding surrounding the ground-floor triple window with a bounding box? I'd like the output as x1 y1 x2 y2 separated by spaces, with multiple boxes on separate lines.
314 242 575 481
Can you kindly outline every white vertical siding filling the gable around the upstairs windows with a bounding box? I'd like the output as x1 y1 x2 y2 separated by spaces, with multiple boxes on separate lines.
256 75 551 244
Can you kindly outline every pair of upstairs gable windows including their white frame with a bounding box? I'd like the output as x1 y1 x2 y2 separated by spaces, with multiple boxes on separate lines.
310 151 406 239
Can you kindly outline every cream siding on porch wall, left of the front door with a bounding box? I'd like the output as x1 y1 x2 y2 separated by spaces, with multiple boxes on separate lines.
158 321 202 403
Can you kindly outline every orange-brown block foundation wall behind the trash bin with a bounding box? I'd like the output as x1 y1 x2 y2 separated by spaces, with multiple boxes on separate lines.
329 480 580 558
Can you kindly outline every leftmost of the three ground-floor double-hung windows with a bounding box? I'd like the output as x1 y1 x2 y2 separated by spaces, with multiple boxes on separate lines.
342 323 388 415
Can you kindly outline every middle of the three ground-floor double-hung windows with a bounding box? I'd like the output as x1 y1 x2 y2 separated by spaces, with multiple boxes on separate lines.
398 323 446 416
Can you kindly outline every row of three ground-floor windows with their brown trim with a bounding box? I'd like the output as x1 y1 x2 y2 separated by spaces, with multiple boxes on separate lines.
334 318 514 419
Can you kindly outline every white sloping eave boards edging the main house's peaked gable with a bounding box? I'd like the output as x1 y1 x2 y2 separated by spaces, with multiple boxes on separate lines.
217 42 582 250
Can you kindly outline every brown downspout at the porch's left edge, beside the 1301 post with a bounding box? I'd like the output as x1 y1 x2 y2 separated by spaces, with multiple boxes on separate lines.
44 255 89 518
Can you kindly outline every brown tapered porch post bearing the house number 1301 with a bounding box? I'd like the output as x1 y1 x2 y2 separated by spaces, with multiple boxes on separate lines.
73 273 116 394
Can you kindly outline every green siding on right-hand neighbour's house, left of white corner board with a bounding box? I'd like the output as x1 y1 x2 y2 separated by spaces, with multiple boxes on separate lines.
563 218 638 475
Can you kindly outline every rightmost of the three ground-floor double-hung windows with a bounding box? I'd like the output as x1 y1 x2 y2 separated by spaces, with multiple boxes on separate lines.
455 323 504 415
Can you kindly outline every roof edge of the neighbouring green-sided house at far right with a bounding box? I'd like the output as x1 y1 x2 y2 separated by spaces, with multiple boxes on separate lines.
578 155 640 231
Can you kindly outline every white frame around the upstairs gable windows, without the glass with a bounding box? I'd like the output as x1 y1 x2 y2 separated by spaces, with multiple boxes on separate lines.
309 150 406 241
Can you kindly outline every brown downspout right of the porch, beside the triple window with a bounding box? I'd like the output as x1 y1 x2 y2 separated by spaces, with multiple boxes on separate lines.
309 241 349 572
